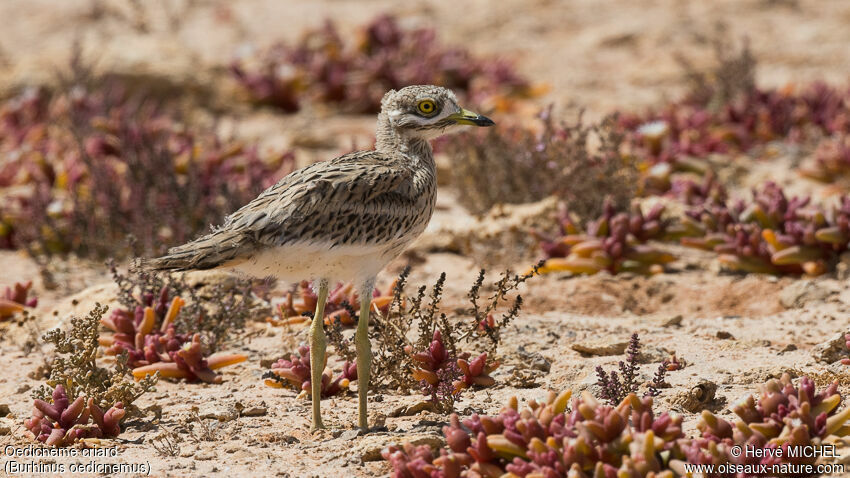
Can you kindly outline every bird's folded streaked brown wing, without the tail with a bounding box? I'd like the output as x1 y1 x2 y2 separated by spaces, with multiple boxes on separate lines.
221 151 414 246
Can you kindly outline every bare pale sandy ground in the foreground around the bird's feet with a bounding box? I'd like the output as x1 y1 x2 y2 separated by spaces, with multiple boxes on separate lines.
0 248 850 477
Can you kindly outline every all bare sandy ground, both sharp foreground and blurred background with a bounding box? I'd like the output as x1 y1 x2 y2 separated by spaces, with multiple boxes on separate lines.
0 0 850 477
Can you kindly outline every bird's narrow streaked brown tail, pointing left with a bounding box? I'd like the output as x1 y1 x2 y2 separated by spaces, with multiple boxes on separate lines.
135 231 252 271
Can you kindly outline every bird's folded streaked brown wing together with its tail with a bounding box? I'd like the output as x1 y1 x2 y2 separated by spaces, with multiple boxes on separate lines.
140 151 414 270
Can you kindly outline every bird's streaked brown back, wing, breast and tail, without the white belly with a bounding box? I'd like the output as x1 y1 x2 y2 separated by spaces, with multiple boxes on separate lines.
148 149 436 281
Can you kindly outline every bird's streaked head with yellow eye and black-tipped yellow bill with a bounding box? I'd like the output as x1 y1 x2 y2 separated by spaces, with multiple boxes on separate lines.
381 85 495 139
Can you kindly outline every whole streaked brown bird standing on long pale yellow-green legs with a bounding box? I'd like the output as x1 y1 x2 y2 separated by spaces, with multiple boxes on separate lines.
143 85 494 429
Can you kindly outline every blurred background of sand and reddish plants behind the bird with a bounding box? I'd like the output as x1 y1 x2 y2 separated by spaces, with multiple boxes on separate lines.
0 0 850 274
